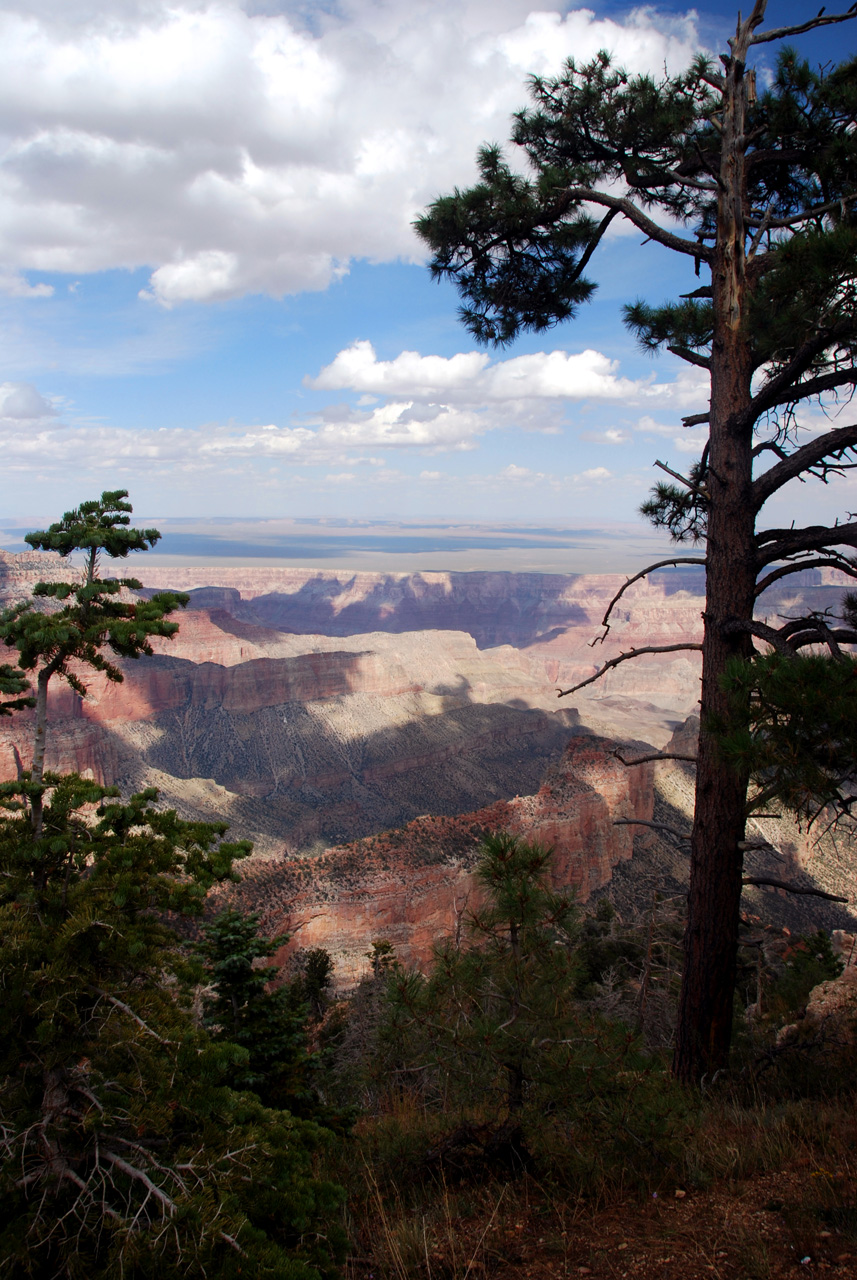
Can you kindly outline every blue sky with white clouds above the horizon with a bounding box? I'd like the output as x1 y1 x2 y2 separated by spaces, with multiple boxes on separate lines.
0 0 857 547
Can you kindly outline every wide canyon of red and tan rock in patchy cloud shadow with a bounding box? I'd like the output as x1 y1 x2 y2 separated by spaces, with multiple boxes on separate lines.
0 553 848 983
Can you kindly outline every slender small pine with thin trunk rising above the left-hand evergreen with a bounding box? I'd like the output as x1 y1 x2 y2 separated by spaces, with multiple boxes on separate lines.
0 489 188 835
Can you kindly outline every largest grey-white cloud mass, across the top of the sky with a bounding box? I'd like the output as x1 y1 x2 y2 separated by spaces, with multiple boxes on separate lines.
0 0 697 303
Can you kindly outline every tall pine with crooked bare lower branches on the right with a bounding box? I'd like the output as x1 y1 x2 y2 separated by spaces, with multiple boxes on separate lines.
416 0 857 1082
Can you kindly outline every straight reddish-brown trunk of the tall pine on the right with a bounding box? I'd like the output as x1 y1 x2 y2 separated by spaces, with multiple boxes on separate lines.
673 19 756 1084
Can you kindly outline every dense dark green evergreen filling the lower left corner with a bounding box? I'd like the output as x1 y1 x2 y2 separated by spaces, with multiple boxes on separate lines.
0 774 342 1280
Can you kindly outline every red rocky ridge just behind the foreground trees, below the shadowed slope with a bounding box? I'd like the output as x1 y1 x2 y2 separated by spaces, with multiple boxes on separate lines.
223 733 654 987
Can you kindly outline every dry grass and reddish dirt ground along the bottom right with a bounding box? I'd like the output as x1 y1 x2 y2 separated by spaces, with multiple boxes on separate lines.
335 1098 857 1280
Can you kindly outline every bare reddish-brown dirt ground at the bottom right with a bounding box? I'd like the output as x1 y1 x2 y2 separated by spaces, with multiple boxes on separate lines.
345 1164 857 1280
